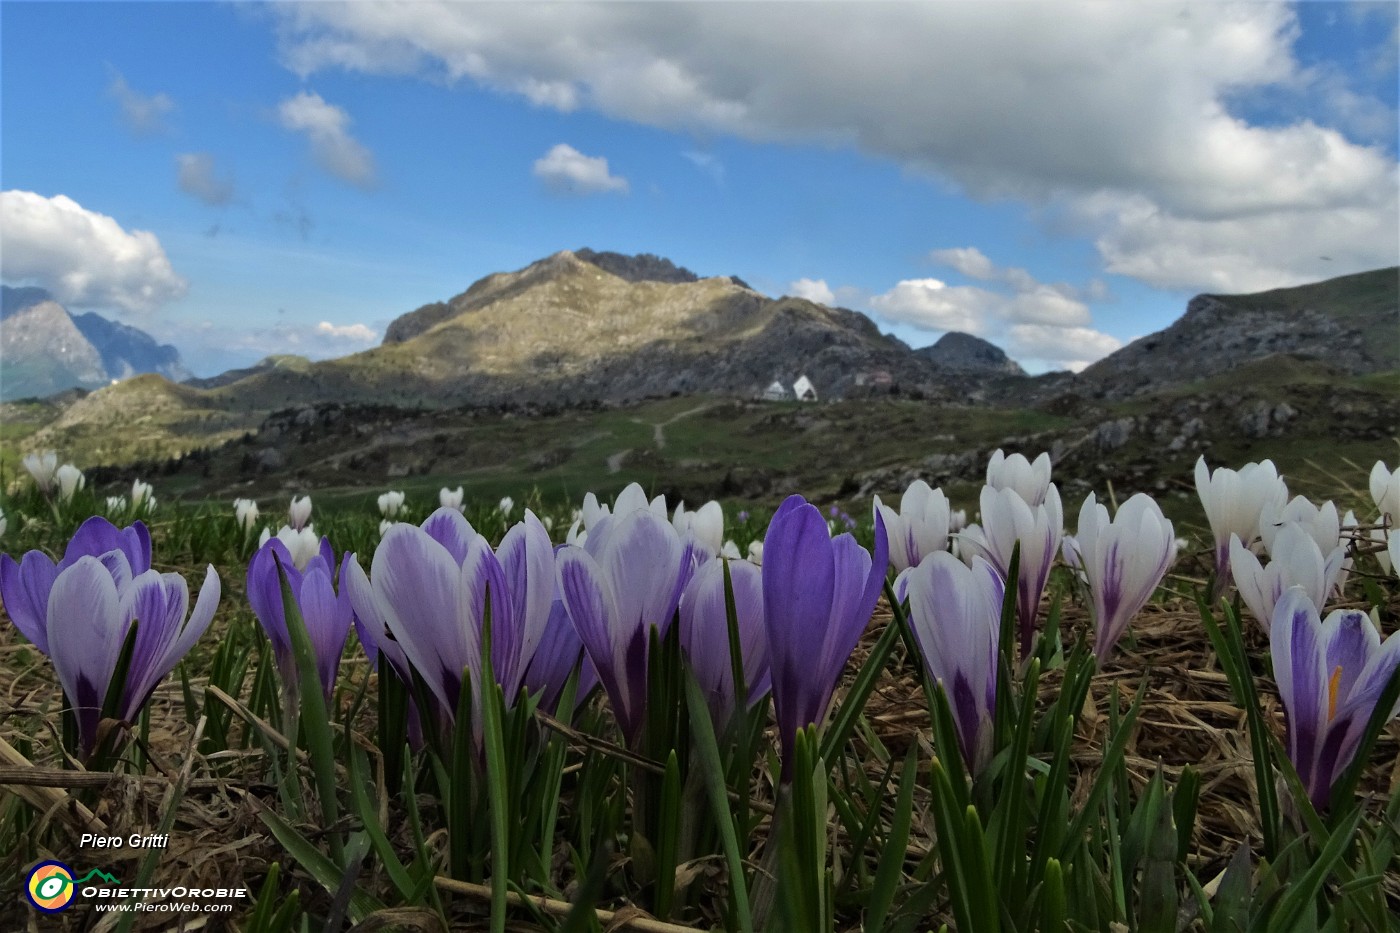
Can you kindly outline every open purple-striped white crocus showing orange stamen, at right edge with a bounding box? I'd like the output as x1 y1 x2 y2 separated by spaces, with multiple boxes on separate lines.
1270 587 1400 808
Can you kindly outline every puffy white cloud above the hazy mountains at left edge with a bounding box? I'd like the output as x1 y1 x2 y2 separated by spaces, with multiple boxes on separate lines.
0 191 186 311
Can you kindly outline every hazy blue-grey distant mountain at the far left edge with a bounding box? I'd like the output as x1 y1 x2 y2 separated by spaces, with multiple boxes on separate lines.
0 286 190 399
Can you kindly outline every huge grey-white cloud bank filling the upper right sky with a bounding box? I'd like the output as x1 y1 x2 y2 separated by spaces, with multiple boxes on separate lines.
274 0 1400 289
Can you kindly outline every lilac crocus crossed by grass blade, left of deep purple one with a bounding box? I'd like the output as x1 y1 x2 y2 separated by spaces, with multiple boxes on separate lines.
680 558 773 730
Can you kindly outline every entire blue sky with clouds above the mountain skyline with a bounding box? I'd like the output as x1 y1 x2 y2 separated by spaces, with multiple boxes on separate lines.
0 0 1400 374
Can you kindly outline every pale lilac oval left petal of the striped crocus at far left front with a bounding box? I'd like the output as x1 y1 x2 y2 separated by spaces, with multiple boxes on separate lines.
48 556 129 756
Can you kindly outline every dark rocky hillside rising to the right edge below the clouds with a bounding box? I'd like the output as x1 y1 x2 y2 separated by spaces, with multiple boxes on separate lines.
1075 268 1400 398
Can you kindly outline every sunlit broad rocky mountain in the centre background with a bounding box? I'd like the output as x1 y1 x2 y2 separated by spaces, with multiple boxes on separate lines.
252 251 941 406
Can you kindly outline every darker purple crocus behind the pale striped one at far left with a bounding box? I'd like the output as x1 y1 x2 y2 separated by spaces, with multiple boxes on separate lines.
0 516 151 654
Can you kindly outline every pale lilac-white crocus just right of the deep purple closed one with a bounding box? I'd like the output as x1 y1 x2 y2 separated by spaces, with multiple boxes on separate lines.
904 551 1005 775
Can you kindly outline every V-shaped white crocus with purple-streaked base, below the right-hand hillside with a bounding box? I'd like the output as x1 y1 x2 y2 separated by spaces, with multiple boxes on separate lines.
1075 493 1176 663
